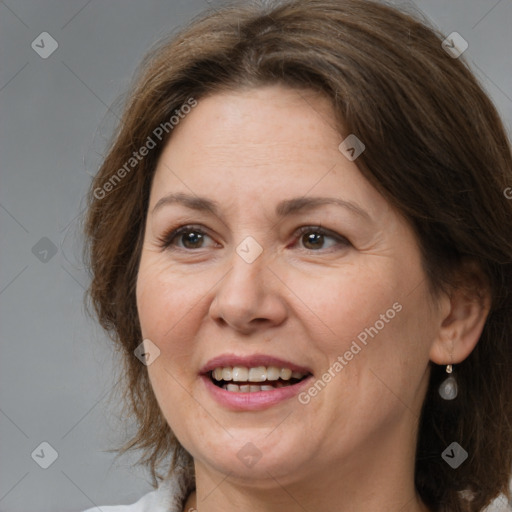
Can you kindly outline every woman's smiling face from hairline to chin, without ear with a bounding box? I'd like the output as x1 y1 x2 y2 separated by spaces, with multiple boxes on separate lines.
137 86 440 485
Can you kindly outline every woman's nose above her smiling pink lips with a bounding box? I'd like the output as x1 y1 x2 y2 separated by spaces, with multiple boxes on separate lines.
209 246 287 334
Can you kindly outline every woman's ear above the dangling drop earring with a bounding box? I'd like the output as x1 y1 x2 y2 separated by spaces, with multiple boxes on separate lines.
430 261 491 365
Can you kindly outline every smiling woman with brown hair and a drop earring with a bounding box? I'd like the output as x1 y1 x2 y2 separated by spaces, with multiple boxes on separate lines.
82 0 512 512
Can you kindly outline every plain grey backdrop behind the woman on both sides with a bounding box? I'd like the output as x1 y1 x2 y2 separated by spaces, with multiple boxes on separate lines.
0 0 512 512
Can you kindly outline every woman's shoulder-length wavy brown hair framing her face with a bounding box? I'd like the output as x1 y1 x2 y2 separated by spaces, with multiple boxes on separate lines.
85 0 512 512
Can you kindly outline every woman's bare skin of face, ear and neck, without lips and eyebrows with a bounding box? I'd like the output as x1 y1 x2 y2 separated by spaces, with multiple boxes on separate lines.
137 86 488 512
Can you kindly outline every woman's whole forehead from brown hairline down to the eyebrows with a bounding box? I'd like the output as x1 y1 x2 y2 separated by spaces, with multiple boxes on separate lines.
150 86 385 220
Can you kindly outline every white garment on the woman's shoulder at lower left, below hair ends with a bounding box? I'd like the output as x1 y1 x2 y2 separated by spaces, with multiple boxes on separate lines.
84 475 193 512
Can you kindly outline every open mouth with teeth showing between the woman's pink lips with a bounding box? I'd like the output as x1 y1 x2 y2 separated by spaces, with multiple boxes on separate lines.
207 366 311 393
